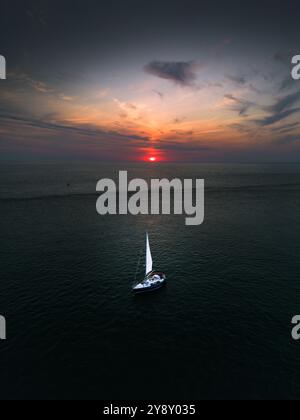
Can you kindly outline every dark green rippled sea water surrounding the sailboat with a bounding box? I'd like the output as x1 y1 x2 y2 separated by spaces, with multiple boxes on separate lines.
0 163 300 400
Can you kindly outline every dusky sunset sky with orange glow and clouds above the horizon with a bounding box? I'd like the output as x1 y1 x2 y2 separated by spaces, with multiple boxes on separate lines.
0 0 300 162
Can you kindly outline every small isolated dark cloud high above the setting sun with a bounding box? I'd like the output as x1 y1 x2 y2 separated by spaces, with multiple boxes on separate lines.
144 61 199 86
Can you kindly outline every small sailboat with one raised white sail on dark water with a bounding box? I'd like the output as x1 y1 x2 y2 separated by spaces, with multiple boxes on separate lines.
132 233 167 293
